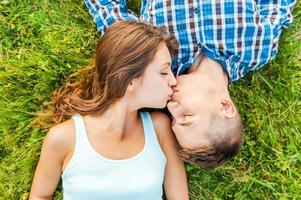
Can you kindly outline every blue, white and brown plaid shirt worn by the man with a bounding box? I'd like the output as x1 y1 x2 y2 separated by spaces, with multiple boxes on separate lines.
85 0 296 81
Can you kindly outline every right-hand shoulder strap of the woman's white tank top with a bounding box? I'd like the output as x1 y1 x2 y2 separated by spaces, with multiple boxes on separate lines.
140 112 161 149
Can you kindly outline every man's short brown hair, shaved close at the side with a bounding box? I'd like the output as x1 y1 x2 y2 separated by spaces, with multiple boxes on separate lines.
179 113 243 167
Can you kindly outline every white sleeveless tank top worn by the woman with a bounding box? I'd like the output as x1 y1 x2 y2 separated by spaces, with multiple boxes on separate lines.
62 112 166 200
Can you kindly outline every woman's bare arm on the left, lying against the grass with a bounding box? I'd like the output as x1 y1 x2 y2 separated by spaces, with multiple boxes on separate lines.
29 121 75 200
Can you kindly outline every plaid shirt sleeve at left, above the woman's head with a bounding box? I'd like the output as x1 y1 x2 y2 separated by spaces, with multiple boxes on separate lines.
84 0 138 34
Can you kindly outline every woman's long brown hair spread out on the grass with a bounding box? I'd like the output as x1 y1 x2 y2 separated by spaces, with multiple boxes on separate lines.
42 21 177 126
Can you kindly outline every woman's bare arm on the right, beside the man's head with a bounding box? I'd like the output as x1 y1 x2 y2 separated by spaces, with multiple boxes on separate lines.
151 112 189 200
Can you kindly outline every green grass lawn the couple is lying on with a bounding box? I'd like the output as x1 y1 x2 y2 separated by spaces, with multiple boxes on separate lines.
0 0 301 200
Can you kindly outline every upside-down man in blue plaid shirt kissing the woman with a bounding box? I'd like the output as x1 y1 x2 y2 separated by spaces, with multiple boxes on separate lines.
85 0 296 167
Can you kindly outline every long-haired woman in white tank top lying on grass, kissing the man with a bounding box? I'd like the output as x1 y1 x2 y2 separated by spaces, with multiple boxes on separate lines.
30 21 188 200
